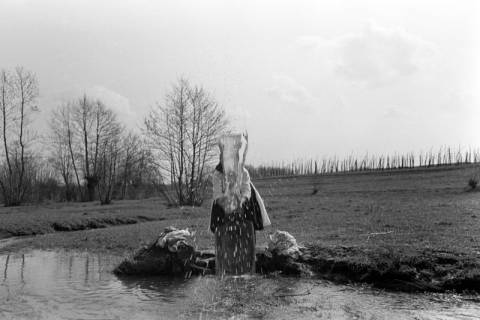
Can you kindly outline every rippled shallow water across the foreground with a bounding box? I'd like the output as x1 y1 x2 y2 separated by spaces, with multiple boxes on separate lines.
0 251 480 319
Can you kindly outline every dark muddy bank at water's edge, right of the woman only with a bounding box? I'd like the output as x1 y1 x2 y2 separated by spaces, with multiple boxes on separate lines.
276 244 480 292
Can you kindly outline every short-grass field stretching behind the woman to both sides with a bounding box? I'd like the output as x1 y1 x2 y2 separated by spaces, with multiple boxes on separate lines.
0 165 480 290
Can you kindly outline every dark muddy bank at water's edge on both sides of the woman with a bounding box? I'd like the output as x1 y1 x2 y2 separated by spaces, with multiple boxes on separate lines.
114 230 480 292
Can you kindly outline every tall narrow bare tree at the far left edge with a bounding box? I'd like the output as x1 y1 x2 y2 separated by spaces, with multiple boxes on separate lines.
0 67 38 206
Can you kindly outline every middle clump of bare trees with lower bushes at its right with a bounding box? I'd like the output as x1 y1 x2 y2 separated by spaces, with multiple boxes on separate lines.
48 95 169 204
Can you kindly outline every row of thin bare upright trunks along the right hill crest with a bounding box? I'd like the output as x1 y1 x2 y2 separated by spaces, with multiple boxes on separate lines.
248 147 480 178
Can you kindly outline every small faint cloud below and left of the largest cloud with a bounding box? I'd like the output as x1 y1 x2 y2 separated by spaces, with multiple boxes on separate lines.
267 75 316 112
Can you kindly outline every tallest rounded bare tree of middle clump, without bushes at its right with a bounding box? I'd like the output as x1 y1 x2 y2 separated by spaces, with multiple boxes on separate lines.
51 95 121 201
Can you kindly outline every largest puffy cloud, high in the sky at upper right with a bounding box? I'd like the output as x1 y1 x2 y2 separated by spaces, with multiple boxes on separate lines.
296 22 437 86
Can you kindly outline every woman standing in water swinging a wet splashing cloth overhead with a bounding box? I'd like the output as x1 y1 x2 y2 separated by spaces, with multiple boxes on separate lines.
210 134 270 275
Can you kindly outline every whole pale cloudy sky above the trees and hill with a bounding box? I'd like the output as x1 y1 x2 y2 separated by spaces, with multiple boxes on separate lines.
0 0 480 164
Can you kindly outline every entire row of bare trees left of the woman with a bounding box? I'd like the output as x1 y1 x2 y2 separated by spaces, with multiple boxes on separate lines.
0 67 227 206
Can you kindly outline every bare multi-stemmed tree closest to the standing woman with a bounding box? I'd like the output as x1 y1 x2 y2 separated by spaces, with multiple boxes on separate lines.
145 79 227 205
